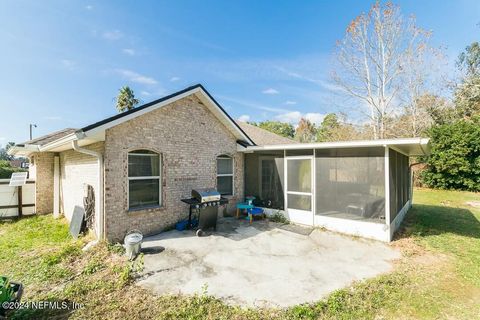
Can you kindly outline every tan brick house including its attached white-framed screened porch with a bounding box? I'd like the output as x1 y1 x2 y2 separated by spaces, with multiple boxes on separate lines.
9 85 428 241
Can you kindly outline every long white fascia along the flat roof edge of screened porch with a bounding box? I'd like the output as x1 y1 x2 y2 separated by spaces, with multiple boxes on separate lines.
245 138 429 151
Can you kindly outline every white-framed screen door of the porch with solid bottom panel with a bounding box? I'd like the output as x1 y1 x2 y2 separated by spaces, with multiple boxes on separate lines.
286 156 313 225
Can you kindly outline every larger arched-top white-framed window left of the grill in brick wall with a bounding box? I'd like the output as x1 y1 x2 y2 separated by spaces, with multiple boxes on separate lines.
128 150 162 209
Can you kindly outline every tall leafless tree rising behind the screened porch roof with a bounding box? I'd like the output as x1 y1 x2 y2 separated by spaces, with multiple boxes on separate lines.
333 2 430 139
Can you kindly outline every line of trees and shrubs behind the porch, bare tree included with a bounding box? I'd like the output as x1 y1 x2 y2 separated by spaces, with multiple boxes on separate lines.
252 2 480 191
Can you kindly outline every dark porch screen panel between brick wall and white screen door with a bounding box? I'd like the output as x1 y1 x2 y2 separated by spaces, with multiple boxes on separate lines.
245 151 285 210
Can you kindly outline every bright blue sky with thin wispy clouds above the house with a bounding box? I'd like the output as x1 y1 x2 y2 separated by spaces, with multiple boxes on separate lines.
0 0 480 145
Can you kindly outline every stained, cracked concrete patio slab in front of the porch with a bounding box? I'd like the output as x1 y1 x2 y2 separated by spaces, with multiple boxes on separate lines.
138 218 400 307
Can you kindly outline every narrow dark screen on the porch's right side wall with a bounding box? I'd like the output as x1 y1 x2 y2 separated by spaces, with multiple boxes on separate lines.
388 149 410 222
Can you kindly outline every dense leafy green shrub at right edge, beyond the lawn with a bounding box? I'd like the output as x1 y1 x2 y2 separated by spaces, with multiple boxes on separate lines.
422 117 480 191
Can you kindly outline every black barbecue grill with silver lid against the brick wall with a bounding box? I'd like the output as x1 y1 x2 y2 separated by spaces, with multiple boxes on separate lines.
181 189 228 236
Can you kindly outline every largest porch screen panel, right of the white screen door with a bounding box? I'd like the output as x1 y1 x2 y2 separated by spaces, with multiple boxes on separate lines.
315 148 385 223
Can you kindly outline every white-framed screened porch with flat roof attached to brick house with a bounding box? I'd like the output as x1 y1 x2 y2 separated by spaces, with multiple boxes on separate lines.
240 139 428 241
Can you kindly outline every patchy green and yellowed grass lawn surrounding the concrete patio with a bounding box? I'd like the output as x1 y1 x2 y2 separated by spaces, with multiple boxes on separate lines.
0 189 480 319
